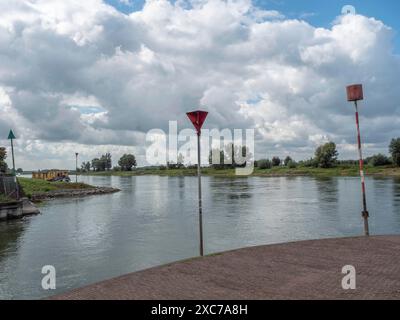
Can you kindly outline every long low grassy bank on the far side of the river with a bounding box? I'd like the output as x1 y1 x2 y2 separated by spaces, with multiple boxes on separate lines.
84 166 400 177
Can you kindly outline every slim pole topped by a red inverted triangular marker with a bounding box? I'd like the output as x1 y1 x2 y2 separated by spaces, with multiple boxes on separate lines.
187 110 208 256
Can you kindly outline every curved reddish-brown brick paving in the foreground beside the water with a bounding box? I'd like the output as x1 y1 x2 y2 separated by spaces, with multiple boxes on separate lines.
50 236 400 300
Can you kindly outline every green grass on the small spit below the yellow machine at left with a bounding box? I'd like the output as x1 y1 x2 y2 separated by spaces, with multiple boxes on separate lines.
18 178 94 198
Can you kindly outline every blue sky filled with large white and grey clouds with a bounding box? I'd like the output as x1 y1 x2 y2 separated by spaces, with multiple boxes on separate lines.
0 0 400 170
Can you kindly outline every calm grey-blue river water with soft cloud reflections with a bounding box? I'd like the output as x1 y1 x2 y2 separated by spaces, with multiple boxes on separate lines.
0 176 400 299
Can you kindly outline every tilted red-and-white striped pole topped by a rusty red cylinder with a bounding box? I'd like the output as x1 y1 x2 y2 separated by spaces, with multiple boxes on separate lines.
347 84 369 236
